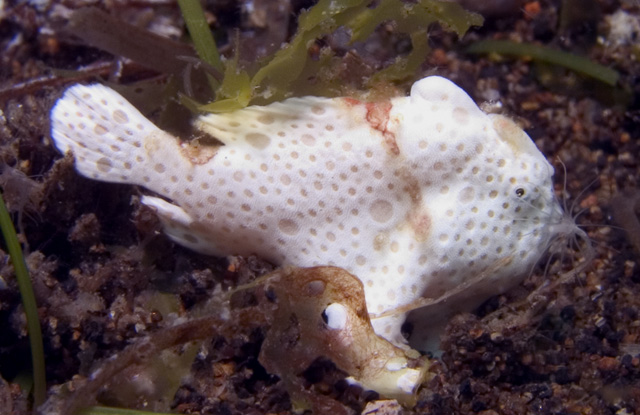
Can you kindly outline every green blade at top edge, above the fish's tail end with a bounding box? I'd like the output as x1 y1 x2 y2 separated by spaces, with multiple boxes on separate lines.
178 0 224 87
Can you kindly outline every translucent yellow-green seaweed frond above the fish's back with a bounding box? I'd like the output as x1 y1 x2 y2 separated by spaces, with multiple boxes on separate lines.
199 0 482 112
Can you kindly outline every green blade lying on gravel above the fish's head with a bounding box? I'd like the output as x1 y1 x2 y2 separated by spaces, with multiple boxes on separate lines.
467 40 620 86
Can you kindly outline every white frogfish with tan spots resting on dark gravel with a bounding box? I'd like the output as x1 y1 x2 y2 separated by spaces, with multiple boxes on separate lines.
51 76 563 344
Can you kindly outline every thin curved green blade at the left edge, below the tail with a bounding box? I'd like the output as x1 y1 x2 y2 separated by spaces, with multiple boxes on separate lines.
0 193 47 408
